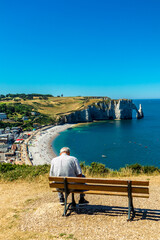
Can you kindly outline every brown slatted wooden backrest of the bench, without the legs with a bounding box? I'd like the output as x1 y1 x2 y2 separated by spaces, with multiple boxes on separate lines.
49 177 149 197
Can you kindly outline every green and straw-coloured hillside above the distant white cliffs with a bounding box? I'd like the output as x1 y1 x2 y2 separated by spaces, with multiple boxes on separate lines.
0 94 110 130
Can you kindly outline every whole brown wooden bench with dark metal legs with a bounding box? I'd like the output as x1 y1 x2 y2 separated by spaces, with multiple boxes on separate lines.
49 177 149 220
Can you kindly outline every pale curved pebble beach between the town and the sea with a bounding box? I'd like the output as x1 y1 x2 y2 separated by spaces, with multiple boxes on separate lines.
28 124 74 165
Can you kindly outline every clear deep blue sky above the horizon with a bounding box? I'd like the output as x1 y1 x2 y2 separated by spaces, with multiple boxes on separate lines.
0 0 160 98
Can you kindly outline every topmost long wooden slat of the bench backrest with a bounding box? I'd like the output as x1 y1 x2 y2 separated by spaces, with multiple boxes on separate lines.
49 177 149 186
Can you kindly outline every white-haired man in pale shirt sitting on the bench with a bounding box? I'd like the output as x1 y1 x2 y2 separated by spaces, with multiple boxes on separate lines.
50 147 89 205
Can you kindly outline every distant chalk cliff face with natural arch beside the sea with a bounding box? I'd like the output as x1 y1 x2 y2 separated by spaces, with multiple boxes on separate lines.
61 100 143 123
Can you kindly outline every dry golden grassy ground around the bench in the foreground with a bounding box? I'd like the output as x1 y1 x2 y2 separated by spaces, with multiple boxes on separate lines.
0 176 160 240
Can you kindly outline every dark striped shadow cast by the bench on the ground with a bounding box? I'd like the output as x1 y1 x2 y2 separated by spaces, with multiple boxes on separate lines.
67 205 160 221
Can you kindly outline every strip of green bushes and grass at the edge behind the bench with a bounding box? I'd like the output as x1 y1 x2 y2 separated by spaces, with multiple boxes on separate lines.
0 162 160 181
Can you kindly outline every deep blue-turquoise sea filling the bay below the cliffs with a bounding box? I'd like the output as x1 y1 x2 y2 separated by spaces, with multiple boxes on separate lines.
52 99 160 169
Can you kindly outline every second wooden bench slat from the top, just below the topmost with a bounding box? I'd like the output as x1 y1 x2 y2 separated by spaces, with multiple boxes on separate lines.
50 183 149 194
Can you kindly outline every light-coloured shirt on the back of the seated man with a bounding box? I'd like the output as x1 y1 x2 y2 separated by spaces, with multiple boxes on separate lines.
50 153 82 177
